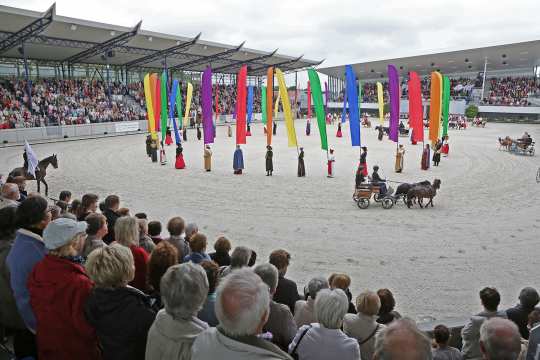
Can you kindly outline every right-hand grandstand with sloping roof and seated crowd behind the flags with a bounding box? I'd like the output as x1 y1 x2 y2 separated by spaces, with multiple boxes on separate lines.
318 40 540 120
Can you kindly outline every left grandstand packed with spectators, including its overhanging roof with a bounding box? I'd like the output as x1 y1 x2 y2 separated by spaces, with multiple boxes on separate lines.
0 4 321 129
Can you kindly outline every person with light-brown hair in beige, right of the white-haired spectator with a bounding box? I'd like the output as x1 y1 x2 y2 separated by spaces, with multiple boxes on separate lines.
343 291 385 359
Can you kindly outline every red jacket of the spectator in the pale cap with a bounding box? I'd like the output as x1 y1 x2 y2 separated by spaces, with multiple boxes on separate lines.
28 255 101 360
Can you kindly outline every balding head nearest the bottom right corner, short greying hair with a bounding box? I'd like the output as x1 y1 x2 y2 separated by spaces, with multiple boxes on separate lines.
480 317 521 360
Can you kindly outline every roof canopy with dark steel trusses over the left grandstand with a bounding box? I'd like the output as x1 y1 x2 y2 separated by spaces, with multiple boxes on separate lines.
0 4 322 75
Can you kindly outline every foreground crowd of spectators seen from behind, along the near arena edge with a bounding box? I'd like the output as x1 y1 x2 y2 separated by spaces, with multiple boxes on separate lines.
0 183 540 360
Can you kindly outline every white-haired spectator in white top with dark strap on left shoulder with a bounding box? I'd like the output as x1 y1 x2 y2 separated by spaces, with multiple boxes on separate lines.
289 289 360 360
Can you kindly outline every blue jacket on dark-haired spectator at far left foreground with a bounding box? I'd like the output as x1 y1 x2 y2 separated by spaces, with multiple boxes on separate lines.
6 229 47 332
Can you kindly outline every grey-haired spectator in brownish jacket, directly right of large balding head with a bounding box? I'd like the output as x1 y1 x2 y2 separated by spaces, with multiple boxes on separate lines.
254 264 298 351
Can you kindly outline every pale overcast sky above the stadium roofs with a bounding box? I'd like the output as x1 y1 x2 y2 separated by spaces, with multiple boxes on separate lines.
4 0 540 81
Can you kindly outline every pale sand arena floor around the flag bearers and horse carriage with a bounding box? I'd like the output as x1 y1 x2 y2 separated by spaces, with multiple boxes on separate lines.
0 120 540 319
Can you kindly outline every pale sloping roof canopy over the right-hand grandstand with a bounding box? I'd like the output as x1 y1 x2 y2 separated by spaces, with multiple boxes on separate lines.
318 40 540 80
